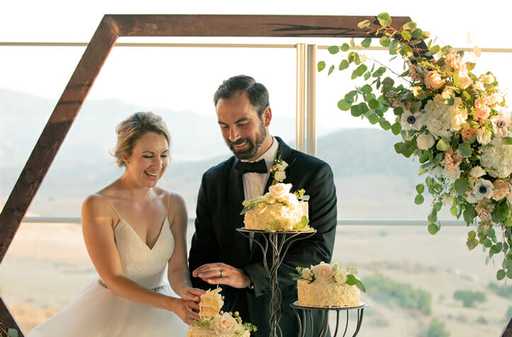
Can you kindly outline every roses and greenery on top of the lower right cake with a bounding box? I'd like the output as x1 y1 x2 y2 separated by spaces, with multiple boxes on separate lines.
296 262 366 291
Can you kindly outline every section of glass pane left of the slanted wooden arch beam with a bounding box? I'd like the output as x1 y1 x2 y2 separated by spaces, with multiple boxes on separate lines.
0 47 84 215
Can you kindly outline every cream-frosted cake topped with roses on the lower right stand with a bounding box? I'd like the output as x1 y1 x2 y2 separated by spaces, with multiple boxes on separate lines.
297 262 365 308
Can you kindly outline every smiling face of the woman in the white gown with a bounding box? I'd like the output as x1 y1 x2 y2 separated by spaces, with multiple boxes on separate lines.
125 132 169 187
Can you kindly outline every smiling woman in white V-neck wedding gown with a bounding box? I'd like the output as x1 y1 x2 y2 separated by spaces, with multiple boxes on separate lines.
29 112 203 337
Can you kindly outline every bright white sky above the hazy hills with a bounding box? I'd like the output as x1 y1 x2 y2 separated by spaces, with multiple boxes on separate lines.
0 0 512 133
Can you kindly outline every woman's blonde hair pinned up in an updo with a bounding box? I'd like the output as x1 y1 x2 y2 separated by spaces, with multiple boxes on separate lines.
114 112 171 167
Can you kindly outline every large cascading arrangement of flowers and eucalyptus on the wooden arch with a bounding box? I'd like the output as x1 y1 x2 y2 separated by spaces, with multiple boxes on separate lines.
318 13 512 280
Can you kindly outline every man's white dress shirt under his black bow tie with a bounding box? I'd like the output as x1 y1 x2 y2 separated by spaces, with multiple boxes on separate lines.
242 137 279 200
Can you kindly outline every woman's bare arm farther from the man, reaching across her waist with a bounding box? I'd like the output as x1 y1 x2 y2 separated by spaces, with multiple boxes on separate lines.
82 195 197 323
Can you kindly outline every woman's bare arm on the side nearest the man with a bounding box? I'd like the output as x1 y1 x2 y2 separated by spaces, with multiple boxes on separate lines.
167 194 204 302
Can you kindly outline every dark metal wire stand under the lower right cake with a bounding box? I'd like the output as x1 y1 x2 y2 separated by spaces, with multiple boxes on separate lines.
290 301 366 337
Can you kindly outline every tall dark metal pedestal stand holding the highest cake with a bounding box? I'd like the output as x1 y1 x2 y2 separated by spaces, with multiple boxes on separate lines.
237 228 316 337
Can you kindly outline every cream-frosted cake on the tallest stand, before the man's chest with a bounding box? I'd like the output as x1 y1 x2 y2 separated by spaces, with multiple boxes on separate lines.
241 183 313 231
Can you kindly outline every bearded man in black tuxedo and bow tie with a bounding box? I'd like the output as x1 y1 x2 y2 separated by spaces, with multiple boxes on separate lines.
189 75 336 337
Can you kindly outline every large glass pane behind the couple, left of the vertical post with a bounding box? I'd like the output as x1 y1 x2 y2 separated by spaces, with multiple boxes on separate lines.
0 47 296 217
